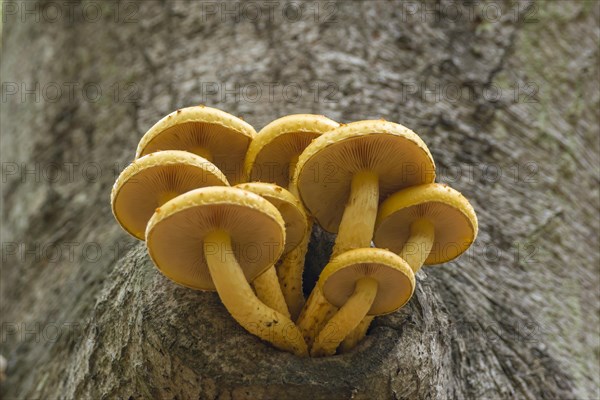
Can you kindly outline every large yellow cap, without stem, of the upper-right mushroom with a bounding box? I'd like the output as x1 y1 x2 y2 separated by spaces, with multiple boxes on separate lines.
294 120 435 232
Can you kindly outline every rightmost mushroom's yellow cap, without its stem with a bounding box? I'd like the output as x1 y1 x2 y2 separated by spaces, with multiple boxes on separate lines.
373 183 478 265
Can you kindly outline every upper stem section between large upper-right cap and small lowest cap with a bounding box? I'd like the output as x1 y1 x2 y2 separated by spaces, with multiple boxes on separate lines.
332 171 379 257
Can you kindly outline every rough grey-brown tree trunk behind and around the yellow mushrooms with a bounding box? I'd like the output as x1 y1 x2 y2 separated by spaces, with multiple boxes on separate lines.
0 0 600 399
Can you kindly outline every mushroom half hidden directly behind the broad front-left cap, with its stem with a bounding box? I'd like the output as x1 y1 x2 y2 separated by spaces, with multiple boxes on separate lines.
236 182 308 318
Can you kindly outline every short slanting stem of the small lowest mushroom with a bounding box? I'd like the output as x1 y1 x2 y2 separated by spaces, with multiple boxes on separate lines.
310 277 377 357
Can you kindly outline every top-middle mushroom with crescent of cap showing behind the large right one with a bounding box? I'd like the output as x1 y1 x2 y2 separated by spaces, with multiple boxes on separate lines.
244 114 339 319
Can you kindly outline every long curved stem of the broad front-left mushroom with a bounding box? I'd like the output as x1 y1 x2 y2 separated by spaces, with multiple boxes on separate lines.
204 230 308 356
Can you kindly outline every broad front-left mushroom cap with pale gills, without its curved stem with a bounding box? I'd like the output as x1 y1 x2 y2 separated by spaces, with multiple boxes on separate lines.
146 187 285 290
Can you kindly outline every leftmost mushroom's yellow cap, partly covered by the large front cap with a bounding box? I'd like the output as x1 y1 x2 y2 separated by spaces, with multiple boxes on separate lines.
110 150 229 240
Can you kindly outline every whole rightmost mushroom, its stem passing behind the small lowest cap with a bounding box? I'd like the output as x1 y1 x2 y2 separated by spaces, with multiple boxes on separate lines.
341 183 478 351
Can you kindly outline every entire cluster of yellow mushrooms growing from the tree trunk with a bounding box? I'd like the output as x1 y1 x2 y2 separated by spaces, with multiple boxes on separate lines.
111 106 477 357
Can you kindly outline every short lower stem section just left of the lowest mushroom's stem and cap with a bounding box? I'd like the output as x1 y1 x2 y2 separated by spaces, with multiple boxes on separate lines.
296 285 337 348
